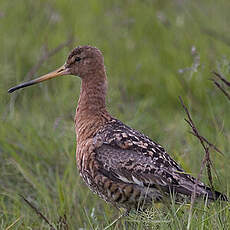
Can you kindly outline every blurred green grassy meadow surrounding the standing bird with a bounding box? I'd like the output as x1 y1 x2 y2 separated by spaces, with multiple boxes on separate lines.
0 0 230 230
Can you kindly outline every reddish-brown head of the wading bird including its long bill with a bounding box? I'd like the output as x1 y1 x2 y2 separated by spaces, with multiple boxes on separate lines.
8 46 105 93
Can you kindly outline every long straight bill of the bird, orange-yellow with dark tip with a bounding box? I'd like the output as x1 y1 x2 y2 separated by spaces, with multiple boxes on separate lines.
8 65 70 93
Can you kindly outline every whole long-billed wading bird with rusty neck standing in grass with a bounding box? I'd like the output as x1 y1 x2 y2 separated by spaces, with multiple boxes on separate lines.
8 46 227 211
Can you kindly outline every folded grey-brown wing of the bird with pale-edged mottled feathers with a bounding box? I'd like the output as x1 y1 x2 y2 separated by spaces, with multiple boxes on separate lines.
95 119 206 195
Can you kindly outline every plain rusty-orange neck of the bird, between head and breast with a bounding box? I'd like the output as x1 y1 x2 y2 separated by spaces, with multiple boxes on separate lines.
75 71 111 143
